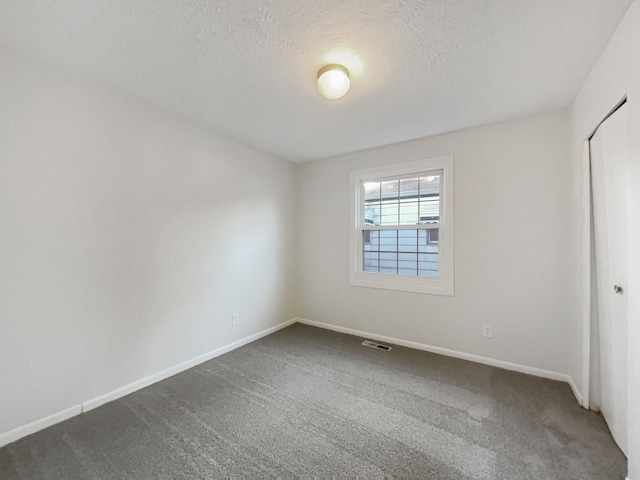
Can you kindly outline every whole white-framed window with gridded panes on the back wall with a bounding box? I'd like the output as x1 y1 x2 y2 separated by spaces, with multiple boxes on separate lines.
350 156 453 295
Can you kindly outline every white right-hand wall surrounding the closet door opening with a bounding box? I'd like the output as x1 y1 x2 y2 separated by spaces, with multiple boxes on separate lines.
569 0 640 480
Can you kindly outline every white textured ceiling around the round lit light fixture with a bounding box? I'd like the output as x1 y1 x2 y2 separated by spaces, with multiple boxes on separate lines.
0 0 632 161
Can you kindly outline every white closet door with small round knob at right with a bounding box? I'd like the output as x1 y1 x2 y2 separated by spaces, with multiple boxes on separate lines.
590 105 629 454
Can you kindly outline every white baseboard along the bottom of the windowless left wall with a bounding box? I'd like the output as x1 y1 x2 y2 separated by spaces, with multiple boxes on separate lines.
0 319 297 447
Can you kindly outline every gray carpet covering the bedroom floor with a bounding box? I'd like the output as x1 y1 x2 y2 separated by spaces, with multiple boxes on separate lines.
0 324 626 480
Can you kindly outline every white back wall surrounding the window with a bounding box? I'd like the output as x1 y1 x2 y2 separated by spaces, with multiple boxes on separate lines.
297 112 572 373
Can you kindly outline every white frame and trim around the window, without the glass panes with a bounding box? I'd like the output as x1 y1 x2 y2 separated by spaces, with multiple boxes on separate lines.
349 155 454 296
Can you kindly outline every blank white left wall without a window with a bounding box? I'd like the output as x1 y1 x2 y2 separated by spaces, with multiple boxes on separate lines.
0 49 295 434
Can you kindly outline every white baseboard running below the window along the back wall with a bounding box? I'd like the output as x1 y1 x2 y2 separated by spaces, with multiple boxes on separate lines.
294 318 582 398
